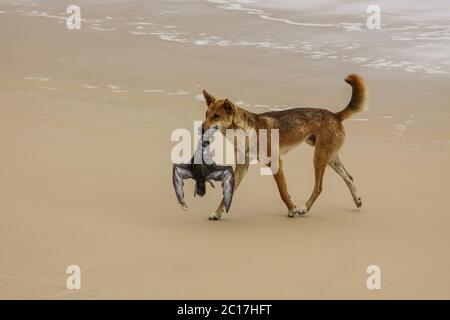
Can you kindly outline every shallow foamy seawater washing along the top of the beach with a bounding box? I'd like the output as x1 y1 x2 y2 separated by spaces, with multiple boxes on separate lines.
0 0 450 76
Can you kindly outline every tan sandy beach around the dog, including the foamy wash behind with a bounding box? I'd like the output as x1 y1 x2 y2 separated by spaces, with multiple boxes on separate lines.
0 0 450 299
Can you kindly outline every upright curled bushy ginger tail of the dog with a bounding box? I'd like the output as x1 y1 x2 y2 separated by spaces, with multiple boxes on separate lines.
336 73 367 121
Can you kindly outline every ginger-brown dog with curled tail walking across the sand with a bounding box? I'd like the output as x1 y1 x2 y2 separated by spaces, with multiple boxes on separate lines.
203 74 367 220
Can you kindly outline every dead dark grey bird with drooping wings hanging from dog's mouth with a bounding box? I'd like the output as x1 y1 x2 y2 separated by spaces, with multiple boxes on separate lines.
172 127 234 212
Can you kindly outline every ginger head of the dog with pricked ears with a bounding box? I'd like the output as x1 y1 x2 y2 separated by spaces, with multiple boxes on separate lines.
202 90 236 132
